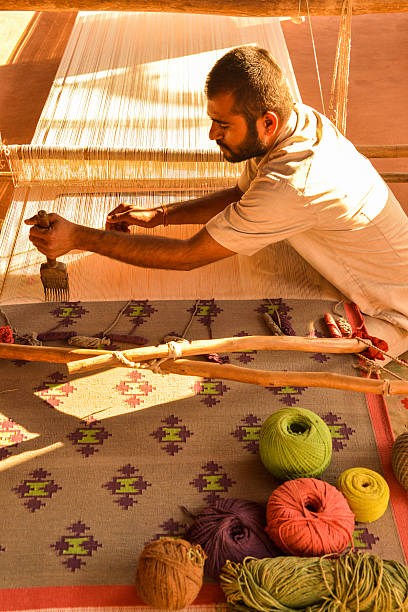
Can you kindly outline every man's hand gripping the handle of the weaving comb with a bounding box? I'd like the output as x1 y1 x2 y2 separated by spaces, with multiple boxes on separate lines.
24 213 77 259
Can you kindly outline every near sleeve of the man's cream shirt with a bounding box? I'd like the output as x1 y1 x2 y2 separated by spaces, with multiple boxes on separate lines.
206 175 314 255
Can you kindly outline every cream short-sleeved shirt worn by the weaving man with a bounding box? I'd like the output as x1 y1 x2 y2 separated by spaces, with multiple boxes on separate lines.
206 104 408 329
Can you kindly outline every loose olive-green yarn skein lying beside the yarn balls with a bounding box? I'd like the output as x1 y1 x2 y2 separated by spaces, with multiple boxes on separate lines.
221 553 408 612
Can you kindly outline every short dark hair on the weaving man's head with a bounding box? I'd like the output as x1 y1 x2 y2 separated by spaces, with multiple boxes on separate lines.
205 46 293 123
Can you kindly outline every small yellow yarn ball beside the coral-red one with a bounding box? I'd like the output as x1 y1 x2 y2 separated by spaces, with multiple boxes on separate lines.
337 467 390 523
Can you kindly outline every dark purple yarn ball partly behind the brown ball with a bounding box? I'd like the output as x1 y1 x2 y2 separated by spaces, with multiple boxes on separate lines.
186 498 282 580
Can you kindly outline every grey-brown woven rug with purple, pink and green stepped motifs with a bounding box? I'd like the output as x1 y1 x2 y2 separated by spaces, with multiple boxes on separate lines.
0 299 408 610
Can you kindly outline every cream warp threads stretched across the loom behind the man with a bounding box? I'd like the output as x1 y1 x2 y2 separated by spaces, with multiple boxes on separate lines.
0 13 339 304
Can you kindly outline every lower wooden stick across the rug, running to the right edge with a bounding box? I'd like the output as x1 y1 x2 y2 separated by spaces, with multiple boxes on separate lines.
160 359 408 395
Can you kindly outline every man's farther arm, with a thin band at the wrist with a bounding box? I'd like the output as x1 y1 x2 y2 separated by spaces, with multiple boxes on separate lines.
106 186 242 229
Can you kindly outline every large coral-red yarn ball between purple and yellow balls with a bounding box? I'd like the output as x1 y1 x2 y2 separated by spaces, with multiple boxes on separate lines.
266 478 354 557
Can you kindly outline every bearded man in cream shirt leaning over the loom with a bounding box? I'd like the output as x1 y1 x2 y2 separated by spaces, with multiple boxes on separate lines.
26 46 408 352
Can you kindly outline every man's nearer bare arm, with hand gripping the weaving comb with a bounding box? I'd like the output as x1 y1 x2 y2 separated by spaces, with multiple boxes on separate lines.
25 213 235 270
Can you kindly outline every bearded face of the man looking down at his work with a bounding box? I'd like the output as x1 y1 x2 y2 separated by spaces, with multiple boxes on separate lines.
207 93 268 163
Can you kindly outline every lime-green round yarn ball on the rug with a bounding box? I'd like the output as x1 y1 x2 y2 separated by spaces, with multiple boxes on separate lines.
259 408 332 480
